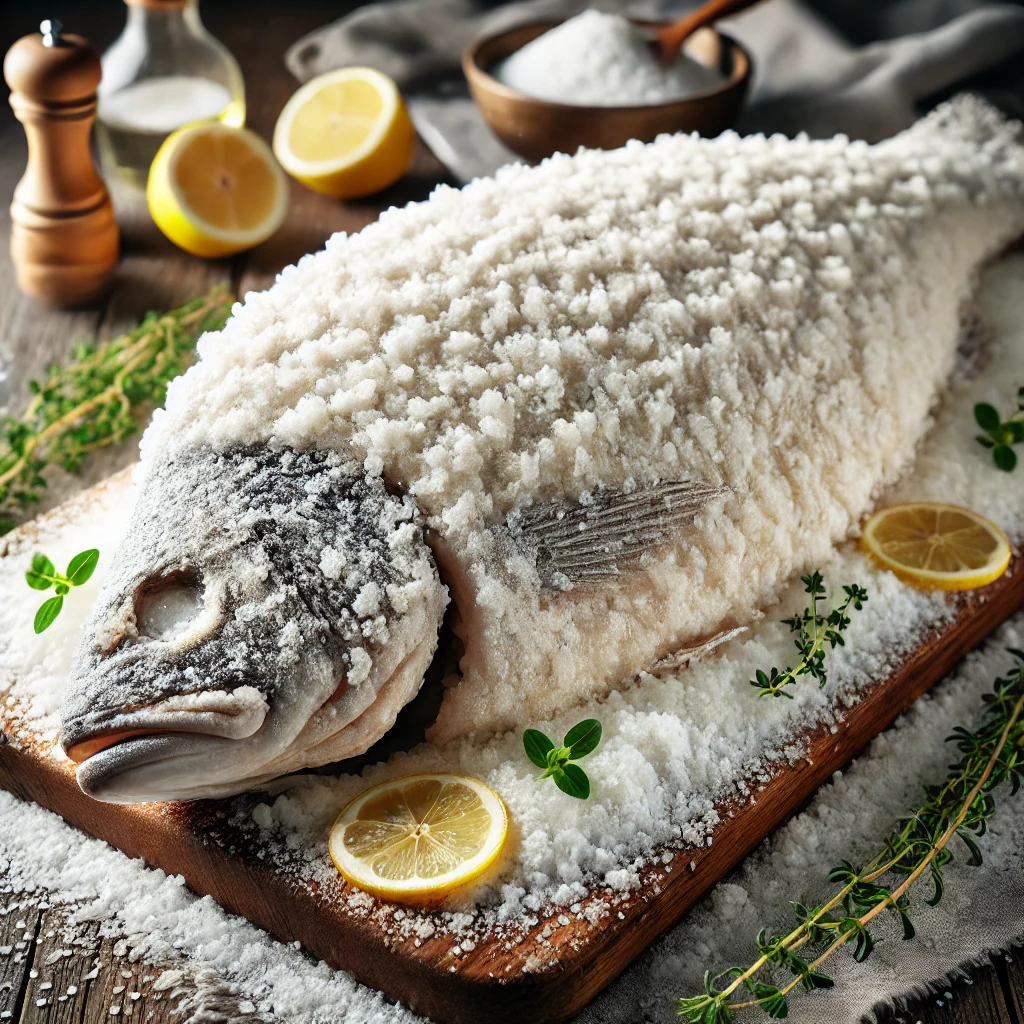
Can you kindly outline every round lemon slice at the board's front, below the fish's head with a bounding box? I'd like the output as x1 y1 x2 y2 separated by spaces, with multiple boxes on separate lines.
331 775 509 903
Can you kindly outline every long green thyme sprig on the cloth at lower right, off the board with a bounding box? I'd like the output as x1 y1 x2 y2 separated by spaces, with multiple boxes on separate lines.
679 649 1024 1024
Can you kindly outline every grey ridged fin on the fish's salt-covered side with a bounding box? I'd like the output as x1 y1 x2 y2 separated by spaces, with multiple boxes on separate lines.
507 480 728 590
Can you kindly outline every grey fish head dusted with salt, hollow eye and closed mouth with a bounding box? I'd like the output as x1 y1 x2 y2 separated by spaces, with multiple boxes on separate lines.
60 445 446 803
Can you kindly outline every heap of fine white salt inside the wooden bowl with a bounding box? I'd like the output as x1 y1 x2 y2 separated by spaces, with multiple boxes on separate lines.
492 10 722 106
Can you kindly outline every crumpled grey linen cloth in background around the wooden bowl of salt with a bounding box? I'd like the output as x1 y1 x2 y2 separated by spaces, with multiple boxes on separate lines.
286 0 1024 181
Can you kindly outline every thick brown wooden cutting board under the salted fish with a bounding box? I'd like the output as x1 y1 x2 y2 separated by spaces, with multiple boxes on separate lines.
0 485 1024 1024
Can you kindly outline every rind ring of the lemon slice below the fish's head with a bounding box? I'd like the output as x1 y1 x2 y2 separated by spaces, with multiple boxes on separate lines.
328 772 509 901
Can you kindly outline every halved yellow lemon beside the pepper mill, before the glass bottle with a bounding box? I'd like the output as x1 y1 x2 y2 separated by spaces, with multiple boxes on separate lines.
145 122 288 257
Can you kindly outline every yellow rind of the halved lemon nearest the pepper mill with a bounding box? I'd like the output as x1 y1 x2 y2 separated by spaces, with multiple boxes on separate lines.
146 121 289 256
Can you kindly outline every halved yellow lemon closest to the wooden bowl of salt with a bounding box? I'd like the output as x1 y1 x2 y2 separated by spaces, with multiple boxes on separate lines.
273 68 416 199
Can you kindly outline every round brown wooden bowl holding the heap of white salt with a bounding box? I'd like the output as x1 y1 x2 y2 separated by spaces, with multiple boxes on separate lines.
462 22 751 162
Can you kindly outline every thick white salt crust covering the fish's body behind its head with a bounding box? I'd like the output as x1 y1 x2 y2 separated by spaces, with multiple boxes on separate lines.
144 97 1024 741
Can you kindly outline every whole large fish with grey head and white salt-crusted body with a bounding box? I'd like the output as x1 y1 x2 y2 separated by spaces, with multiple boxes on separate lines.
61 98 1024 801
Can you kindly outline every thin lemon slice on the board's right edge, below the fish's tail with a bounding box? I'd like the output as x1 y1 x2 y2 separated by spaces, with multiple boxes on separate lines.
860 502 1011 590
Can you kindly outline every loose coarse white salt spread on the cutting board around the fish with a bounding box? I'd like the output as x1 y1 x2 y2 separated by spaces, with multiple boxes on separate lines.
6 255 1024 925
